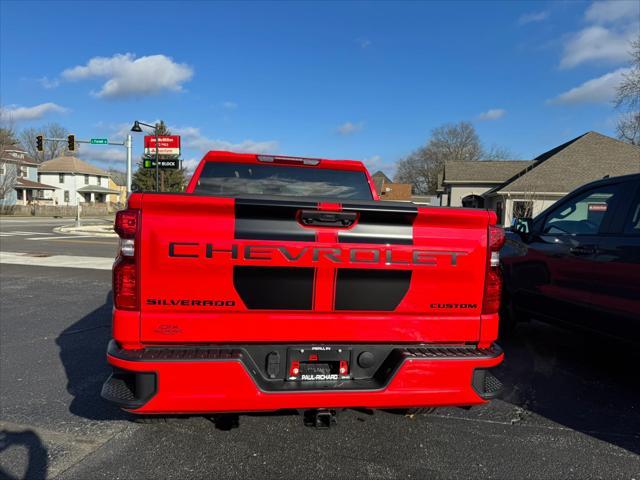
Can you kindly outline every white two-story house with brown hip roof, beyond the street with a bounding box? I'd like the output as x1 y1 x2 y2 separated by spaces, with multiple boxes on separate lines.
38 156 119 206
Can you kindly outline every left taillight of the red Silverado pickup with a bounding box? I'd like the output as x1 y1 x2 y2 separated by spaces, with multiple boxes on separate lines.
113 210 139 310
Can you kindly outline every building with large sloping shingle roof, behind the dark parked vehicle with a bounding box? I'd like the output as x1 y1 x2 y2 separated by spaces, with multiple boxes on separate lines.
478 132 640 226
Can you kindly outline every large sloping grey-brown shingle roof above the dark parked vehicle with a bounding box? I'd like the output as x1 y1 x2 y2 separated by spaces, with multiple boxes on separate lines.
485 132 640 195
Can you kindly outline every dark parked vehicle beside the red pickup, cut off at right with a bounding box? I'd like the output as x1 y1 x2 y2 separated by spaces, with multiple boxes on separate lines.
500 174 640 343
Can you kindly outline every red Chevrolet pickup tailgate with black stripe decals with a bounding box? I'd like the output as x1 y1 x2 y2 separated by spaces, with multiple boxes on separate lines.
137 194 489 344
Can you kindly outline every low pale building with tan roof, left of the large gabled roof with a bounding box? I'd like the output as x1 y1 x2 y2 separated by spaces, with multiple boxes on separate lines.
436 160 532 208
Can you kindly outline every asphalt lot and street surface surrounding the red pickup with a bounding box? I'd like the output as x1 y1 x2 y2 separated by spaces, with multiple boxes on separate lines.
0 219 640 479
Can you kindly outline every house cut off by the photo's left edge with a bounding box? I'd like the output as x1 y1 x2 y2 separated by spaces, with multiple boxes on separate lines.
0 148 56 206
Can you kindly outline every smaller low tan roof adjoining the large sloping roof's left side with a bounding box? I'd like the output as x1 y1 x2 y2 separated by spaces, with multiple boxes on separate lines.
439 160 532 184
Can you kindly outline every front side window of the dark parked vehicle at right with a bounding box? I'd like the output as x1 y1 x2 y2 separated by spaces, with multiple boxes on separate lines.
542 185 620 235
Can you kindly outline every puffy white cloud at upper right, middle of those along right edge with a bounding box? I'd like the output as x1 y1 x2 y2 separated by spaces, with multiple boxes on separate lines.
560 25 637 68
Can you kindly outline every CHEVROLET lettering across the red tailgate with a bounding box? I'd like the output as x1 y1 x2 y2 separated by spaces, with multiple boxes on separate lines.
168 242 465 266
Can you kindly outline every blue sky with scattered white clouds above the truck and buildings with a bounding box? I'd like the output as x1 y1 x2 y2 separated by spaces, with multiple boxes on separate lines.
0 0 640 175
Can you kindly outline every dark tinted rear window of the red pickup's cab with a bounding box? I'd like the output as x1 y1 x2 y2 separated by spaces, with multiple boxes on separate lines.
194 162 373 200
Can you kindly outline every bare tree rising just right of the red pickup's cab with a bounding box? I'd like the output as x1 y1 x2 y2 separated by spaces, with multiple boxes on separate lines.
394 122 513 194
